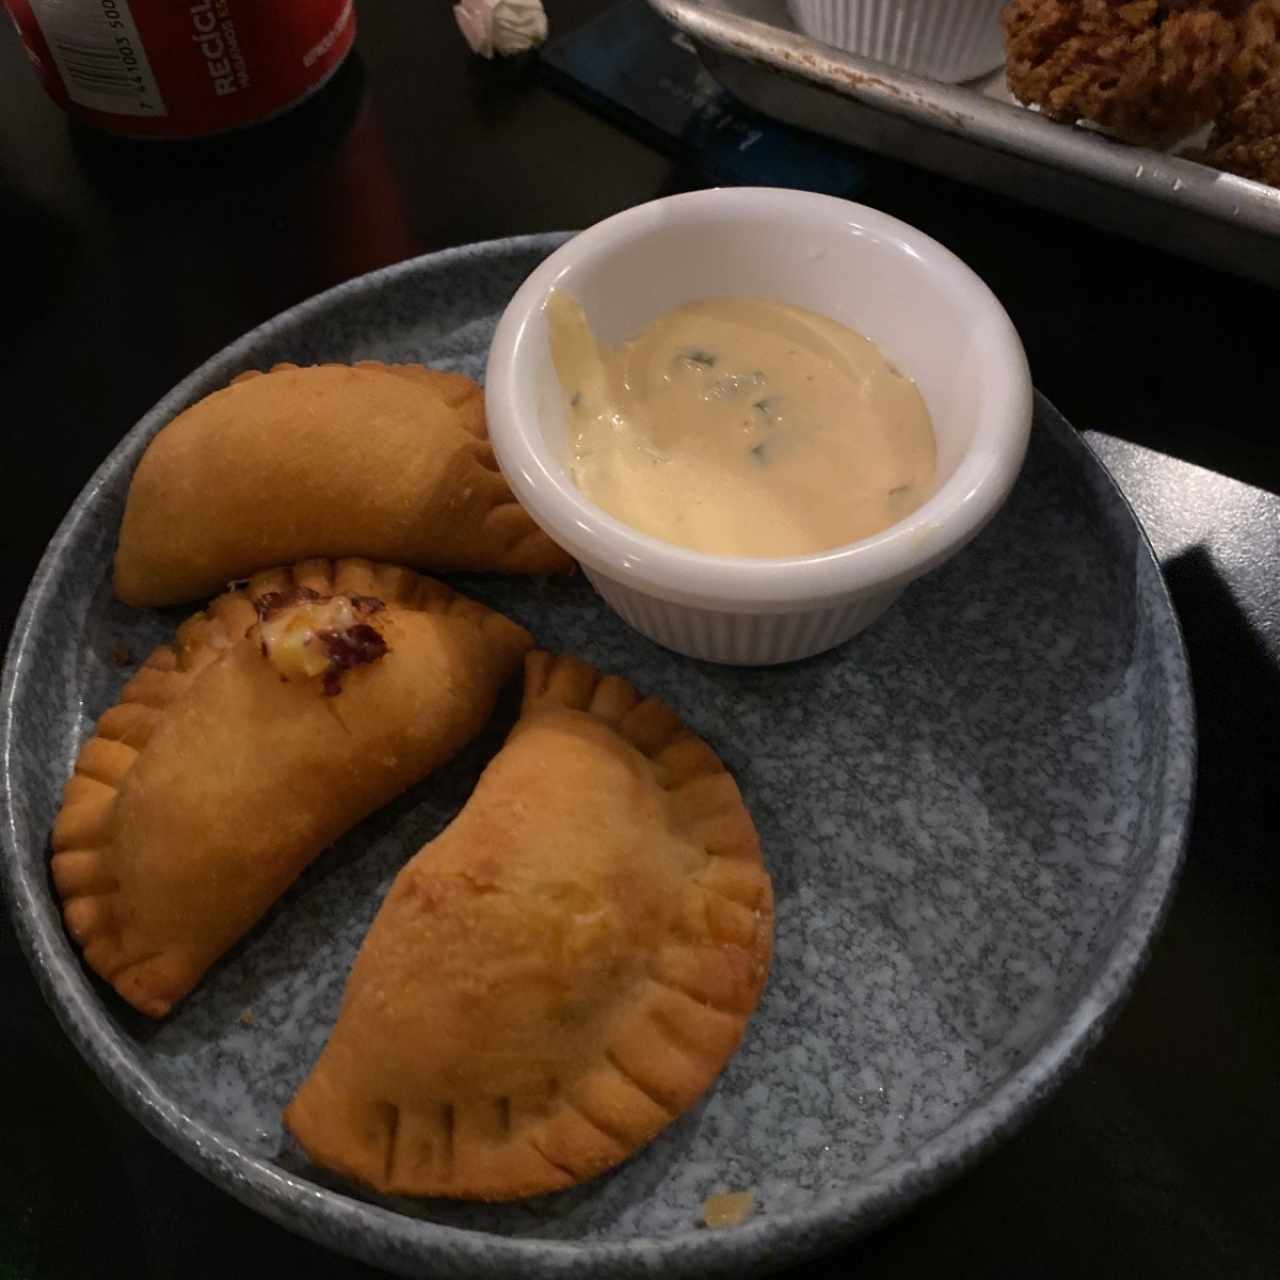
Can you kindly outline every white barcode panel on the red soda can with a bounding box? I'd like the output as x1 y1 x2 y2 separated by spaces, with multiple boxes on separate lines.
31 0 168 115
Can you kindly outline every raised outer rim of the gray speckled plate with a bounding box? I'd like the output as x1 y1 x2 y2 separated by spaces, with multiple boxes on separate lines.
0 232 1197 1276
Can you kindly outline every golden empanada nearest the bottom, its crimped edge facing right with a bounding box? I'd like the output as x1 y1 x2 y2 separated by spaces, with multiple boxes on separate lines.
284 653 773 1199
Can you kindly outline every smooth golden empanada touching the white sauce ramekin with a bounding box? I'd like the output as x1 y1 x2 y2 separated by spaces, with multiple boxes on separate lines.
115 364 572 605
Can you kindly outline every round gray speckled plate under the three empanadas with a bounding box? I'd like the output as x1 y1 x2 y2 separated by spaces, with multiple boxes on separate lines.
0 237 1194 1277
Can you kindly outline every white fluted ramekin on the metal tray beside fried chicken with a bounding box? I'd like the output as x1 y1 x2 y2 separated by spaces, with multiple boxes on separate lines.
787 0 1007 84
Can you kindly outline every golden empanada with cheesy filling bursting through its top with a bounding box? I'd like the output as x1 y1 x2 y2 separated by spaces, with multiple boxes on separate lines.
52 559 532 1018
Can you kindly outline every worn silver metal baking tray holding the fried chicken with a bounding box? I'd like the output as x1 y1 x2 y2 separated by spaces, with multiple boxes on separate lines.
649 0 1280 287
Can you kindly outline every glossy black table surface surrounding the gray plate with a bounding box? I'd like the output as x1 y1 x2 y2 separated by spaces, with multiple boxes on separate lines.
0 0 1280 1280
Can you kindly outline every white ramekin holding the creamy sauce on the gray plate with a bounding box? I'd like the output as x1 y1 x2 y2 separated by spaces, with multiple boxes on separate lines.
485 187 1032 666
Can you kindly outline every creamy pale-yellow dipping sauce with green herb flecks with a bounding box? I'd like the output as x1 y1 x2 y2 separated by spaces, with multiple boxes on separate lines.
547 289 936 557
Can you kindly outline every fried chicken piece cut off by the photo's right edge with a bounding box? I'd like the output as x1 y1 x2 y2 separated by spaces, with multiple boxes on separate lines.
1203 0 1280 187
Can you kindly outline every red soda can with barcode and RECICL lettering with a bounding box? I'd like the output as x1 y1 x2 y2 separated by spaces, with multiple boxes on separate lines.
4 0 356 138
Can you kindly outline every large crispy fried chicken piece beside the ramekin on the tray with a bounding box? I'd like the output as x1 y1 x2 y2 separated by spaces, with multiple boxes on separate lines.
1001 0 1242 143
